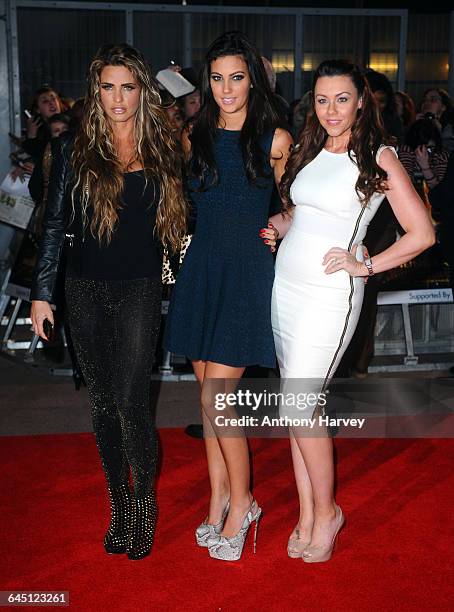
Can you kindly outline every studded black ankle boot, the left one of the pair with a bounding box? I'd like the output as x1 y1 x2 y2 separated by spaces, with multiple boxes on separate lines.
104 484 132 554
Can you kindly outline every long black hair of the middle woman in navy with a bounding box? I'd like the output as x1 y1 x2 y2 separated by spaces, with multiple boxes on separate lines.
188 31 280 191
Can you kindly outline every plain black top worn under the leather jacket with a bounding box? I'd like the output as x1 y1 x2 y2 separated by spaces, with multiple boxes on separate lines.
80 170 162 280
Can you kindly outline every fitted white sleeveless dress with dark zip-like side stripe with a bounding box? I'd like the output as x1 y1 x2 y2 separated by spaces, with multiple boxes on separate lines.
271 146 395 406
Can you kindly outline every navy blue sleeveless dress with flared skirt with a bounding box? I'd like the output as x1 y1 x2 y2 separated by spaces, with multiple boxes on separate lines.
164 129 276 368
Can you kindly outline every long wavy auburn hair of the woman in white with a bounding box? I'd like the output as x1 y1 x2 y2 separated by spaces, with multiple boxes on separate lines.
280 60 394 210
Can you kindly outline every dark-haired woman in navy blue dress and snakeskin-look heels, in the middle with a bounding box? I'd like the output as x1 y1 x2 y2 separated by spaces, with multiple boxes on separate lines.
165 32 291 560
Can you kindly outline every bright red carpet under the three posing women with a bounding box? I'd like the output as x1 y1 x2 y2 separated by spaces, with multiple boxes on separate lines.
0 429 454 612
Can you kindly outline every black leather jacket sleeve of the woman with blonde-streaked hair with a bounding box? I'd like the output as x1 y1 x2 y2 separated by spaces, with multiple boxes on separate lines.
30 132 82 303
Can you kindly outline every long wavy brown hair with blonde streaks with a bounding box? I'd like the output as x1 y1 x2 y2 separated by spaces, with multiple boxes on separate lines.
72 43 187 251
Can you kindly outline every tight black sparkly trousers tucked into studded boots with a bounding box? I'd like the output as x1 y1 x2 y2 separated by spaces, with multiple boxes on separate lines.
65 277 162 497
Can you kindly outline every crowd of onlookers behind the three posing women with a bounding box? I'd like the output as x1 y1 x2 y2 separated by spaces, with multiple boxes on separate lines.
7 57 454 306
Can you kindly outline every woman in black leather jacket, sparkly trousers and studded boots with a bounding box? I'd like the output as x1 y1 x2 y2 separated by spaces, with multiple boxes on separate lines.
31 44 186 559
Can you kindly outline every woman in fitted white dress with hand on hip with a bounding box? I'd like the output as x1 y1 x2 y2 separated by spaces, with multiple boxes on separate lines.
270 60 434 563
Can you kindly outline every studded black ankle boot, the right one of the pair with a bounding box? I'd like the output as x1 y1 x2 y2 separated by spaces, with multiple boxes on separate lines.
128 491 158 560
